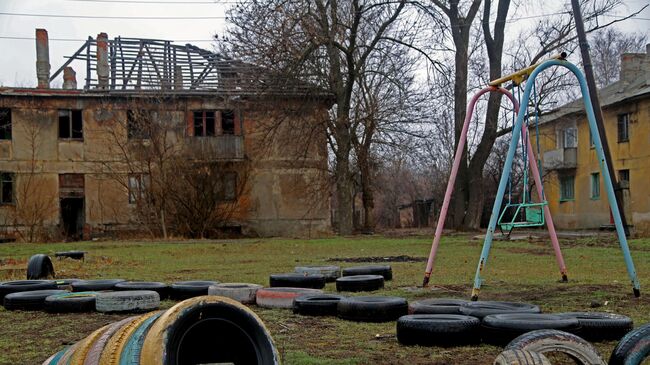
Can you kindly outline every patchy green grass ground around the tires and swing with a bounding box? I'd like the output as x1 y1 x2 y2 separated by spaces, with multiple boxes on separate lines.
0 235 650 365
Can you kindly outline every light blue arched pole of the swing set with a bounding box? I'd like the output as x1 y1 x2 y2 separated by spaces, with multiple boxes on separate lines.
472 59 641 300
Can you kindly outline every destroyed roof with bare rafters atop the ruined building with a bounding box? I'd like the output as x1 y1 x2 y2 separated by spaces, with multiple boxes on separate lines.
50 34 330 97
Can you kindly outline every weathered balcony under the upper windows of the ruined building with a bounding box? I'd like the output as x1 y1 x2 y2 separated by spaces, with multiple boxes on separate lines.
185 134 244 161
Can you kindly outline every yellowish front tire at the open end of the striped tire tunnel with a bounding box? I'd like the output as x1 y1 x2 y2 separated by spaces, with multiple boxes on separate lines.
140 296 280 365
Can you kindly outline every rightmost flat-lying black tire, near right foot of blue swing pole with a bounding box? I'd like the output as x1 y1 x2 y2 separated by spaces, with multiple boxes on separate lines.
558 312 634 342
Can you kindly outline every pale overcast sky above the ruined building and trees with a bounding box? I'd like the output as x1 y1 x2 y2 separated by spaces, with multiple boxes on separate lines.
0 0 650 87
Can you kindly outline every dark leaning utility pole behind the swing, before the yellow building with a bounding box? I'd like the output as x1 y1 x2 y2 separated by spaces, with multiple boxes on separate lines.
571 0 630 237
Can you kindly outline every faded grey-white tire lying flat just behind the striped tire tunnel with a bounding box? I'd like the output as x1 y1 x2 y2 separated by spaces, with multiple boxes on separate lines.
95 290 160 313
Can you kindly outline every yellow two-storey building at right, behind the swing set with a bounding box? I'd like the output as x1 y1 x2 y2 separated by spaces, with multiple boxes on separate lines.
531 45 650 235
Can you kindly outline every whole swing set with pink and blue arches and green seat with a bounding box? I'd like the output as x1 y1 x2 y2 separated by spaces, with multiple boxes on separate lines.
422 53 641 300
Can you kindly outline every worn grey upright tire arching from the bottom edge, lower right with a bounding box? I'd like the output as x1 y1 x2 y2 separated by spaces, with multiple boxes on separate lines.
506 330 605 365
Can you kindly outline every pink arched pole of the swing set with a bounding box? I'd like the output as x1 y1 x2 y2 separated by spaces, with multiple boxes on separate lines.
422 86 567 287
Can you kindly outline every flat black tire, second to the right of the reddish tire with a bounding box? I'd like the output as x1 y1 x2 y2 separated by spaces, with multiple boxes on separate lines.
337 296 408 322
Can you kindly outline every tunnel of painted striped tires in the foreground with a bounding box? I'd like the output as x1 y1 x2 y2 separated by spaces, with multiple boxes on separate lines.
43 296 279 365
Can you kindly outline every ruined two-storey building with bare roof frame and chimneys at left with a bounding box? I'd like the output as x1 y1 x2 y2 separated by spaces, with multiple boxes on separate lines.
0 29 331 240
